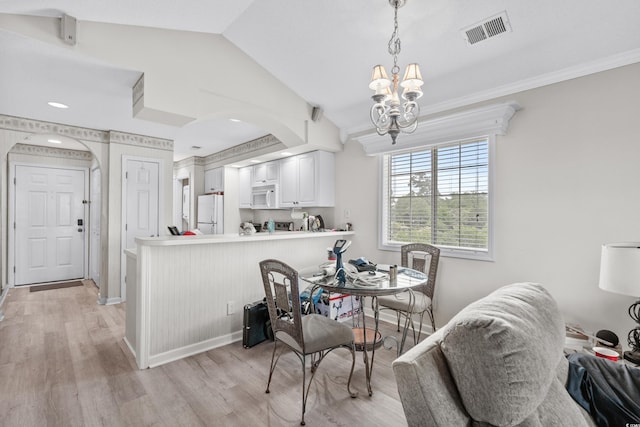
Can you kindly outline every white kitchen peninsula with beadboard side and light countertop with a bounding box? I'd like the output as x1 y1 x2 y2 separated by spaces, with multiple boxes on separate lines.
125 231 354 369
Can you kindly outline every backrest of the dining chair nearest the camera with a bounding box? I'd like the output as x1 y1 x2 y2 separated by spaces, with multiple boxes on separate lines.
260 259 304 349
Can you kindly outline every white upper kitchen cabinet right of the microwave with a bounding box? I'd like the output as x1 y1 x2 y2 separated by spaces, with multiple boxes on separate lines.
280 151 335 208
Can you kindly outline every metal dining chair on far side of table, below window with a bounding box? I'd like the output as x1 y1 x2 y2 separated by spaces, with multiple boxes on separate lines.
378 243 440 344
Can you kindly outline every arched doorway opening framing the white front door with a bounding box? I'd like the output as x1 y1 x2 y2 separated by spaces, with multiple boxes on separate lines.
6 134 101 286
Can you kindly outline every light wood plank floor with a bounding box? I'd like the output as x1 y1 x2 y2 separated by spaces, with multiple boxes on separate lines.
0 281 406 427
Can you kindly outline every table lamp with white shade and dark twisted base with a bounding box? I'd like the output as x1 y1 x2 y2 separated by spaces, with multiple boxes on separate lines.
599 242 640 364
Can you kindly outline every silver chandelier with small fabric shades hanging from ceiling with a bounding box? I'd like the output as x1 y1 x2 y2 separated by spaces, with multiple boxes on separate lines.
369 0 423 144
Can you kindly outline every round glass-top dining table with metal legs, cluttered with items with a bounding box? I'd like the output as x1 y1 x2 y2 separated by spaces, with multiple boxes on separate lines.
299 266 427 396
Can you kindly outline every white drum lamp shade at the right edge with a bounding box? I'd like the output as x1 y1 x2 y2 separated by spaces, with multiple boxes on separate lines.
598 242 640 297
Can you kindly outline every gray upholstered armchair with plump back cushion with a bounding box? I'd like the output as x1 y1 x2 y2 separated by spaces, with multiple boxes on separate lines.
393 283 595 427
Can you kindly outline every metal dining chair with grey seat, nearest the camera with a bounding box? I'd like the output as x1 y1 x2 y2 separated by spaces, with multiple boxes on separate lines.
260 259 356 425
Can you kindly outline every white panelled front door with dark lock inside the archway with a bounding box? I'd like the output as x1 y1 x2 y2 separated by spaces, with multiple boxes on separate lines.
14 165 87 285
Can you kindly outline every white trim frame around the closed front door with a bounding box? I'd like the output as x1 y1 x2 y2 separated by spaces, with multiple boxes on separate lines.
7 161 90 287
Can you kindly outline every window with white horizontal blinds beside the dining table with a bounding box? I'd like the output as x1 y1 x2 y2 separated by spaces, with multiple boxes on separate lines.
382 138 490 254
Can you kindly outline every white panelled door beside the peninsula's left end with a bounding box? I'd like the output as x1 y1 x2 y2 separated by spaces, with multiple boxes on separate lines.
120 159 160 301
